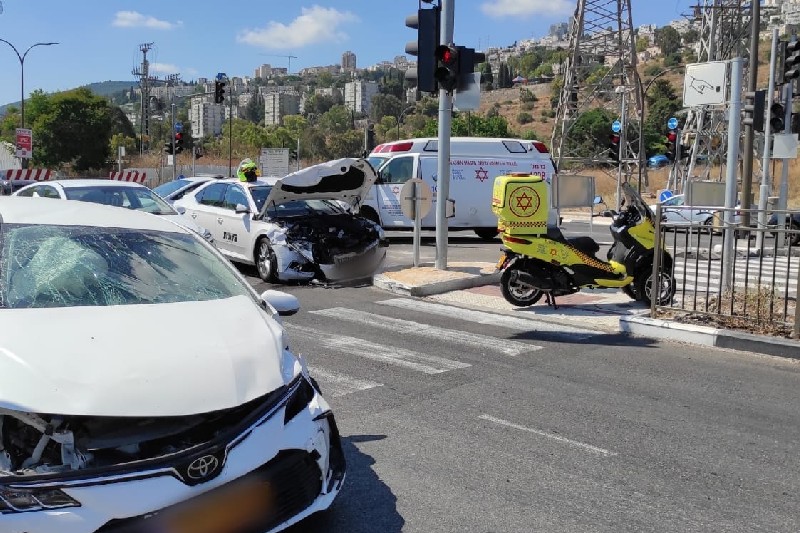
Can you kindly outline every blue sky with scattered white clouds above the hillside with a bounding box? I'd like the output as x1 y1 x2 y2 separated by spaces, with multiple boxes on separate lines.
0 0 694 105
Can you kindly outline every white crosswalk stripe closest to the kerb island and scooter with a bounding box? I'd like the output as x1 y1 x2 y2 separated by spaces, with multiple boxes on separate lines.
378 298 603 340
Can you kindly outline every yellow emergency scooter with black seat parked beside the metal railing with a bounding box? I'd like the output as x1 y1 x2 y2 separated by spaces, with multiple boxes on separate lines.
492 174 675 307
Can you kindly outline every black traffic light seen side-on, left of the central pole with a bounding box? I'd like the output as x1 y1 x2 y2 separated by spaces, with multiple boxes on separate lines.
405 6 441 93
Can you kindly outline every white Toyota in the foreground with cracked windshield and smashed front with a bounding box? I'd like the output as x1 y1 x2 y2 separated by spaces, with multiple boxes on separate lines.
0 197 345 533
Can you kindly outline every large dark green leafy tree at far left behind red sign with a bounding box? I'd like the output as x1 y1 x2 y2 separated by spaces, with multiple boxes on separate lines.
33 88 112 171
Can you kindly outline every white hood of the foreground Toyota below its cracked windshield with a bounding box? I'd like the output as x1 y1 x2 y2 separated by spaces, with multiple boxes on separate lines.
0 296 284 417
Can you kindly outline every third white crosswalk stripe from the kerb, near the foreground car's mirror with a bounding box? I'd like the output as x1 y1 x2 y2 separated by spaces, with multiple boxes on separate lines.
284 324 472 374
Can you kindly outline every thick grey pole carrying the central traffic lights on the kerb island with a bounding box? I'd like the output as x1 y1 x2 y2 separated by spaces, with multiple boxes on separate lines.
435 0 455 270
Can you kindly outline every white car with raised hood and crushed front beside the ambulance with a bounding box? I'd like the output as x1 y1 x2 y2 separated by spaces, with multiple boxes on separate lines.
174 159 388 282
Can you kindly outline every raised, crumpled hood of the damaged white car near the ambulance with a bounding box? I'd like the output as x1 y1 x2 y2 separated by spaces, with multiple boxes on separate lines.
261 158 378 216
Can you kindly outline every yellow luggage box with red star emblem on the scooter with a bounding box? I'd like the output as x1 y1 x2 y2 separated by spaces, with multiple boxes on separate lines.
492 173 550 235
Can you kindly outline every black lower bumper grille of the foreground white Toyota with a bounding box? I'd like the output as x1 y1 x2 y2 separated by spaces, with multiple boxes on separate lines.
95 450 322 533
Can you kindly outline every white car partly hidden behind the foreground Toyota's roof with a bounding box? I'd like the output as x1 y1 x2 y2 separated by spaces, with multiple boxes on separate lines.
13 179 214 243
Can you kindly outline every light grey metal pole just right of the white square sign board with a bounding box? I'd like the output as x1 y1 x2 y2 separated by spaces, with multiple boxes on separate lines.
722 57 746 290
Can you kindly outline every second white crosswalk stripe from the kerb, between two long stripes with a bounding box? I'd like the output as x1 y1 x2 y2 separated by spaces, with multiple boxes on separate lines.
311 307 542 357
